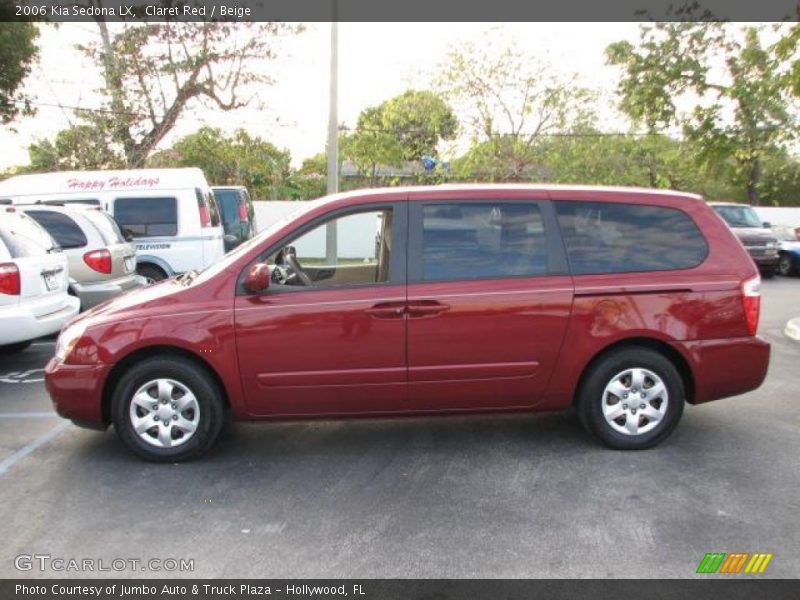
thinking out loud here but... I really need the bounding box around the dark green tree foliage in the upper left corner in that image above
[0,22,39,123]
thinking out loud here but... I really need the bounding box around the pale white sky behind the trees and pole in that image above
[0,23,639,169]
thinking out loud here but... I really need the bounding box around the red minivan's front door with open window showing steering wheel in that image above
[235,202,407,416]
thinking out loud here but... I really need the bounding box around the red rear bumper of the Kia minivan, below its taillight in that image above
[673,337,770,404]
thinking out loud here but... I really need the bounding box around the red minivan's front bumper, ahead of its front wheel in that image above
[44,357,111,429]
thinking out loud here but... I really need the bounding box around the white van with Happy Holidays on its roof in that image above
[0,169,225,281]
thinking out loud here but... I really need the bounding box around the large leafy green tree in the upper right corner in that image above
[606,22,797,205]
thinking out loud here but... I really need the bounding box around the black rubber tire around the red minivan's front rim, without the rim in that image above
[111,355,225,462]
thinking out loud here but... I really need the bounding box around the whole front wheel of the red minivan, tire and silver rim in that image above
[112,356,225,462]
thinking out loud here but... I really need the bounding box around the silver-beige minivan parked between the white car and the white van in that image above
[18,204,145,310]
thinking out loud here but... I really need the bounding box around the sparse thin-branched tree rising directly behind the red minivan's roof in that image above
[437,42,595,181]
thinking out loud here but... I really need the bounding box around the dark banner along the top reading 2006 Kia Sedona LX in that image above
[0,0,798,22]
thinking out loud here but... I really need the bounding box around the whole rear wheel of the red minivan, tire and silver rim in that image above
[578,348,685,450]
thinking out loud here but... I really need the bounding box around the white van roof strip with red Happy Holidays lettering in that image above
[0,168,208,197]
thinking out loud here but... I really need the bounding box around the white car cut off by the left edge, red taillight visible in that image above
[0,207,78,353]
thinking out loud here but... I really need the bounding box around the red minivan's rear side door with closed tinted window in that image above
[407,193,573,411]
